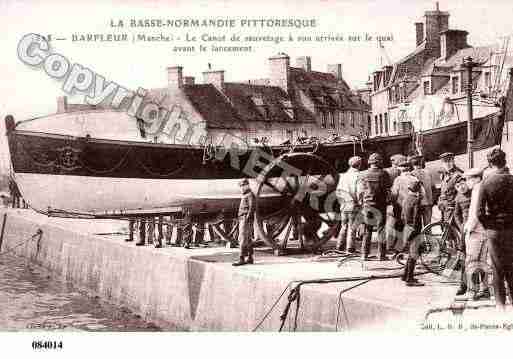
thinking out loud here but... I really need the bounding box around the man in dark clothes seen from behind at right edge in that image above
[477,148,513,309]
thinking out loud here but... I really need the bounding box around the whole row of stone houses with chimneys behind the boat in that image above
[58,3,511,144]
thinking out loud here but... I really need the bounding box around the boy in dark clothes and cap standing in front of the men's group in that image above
[401,178,424,287]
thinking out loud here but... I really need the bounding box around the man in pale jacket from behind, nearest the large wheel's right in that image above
[337,156,362,253]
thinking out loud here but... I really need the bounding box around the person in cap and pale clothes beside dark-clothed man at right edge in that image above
[463,168,490,300]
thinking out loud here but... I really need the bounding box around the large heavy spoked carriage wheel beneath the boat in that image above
[255,153,339,252]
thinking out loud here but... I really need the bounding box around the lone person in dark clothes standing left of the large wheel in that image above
[233,178,255,266]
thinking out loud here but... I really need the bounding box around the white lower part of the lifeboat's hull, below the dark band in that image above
[16,173,286,218]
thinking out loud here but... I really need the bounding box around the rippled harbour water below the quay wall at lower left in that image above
[0,253,163,331]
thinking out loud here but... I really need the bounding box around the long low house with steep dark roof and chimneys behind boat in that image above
[58,53,370,145]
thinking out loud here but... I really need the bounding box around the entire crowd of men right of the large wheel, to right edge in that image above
[337,148,513,307]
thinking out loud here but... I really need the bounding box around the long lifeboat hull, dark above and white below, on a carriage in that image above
[6,108,504,217]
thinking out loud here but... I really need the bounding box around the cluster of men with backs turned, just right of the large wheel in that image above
[337,153,434,286]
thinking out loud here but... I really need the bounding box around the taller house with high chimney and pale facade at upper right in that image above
[370,3,513,136]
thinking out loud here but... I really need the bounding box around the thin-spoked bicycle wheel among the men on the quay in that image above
[419,221,459,272]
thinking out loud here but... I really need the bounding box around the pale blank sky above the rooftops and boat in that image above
[0,0,513,172]
